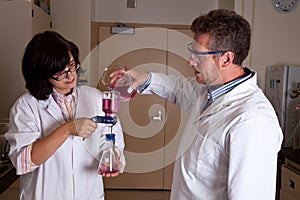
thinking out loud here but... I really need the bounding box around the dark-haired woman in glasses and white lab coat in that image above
[5,31,125,200]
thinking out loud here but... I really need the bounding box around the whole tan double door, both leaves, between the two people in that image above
[98,27,193,189]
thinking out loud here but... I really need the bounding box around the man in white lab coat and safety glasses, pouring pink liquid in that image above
[115,9,283,200]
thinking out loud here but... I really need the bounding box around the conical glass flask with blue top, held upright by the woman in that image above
[98,134,120,175]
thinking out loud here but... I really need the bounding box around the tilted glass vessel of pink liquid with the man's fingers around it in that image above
[100,63,137,101]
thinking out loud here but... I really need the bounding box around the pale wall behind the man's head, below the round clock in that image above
[236,0,300,89]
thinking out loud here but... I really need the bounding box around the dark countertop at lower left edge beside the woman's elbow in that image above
[0,162,18,194]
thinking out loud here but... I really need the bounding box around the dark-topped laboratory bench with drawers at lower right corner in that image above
[276,148,300,200]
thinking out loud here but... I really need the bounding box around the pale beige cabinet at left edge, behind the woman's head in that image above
[0,1,50,119]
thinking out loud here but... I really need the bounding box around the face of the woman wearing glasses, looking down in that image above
[49,54,77,95]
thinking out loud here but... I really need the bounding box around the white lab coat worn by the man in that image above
[143,73,283,200]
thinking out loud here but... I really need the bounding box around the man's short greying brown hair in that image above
[191,9,251,65]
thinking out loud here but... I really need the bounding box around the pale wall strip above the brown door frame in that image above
[93,0,218,25]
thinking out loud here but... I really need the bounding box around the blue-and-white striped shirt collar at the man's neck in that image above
[202,67,255,112]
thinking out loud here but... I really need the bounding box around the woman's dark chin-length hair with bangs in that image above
[22,31,80,100]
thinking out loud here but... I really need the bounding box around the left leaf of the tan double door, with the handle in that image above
[99,27,167,189]
